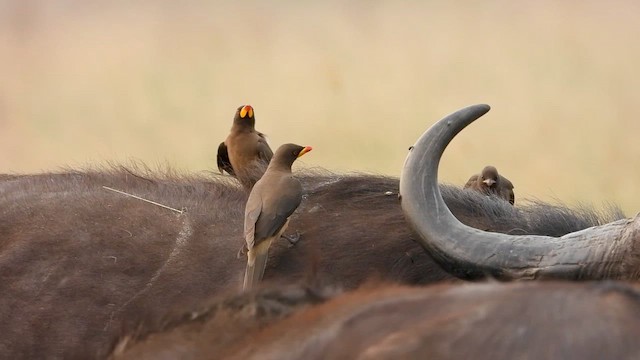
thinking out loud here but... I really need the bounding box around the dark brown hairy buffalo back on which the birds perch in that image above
[0,168,615,358]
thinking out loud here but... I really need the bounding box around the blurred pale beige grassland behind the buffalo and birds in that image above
[0,0,640,215]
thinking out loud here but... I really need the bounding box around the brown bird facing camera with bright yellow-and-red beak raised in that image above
[217,105,273,189]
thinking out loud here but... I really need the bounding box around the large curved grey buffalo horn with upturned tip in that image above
[400,105,640,280]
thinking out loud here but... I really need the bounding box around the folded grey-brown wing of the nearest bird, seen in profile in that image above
[255,177,302,241]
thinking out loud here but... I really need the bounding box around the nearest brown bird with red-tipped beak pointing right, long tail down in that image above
[243,144,311,289]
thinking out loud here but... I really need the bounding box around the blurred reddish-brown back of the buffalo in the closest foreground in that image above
[114,282,640,360]
